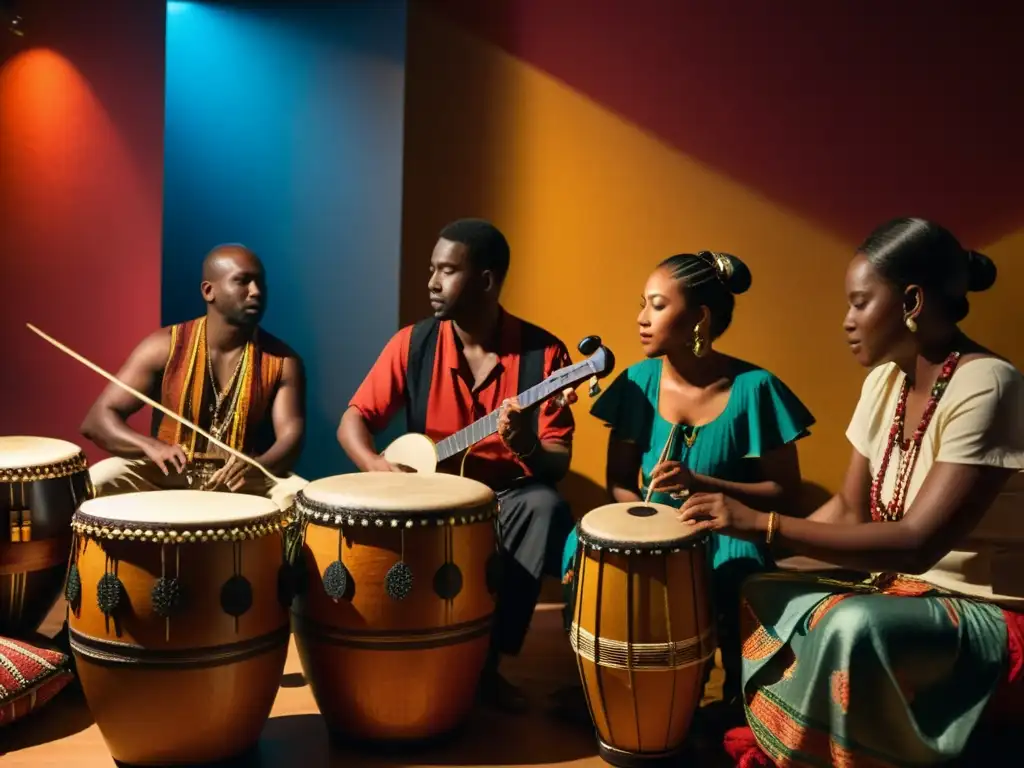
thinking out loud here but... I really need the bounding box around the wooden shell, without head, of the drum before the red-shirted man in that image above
[293,493,497,742]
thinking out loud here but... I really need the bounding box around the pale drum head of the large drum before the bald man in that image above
[75,490,282,531]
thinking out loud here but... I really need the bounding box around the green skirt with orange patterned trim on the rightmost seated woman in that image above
[740,572,1009,768]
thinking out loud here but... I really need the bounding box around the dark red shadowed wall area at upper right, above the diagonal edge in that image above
[425,0,1024,244]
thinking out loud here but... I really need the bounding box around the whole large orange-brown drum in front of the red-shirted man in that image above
[293,472,498,743]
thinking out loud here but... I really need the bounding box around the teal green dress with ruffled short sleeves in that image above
[562,358,814,687]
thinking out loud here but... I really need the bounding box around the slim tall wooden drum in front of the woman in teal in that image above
[569,502,716,767]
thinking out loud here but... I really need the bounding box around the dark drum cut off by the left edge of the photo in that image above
[0,436,92,637]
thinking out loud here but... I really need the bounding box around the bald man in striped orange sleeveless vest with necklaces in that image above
[81,245,305,508]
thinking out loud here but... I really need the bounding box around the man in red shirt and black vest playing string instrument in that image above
[338,219,574,710]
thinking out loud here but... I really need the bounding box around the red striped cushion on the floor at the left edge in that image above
[0,637,75,726]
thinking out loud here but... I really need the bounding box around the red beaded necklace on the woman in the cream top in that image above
[870,352,961,522]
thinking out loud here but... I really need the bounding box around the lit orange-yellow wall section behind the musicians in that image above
[401,2,1024,514]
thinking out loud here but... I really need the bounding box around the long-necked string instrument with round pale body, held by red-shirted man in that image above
[381,336,615,473]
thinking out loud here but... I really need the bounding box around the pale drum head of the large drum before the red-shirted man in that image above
[295,472,498,525]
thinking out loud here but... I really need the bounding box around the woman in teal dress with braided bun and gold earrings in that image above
[563,251,814,701]
